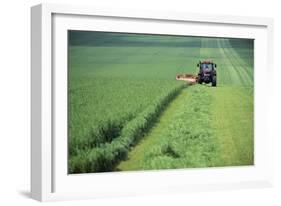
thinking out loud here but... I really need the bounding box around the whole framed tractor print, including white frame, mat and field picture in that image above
[31,4,274,201]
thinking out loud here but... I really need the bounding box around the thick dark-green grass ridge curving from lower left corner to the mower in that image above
[69,85,186,174]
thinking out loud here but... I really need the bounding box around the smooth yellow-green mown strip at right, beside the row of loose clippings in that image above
[211,87,254,166]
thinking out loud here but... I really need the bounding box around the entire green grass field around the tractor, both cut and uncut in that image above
[68,31,254,173]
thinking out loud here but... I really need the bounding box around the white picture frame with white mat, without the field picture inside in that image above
[31,4,274,201]
